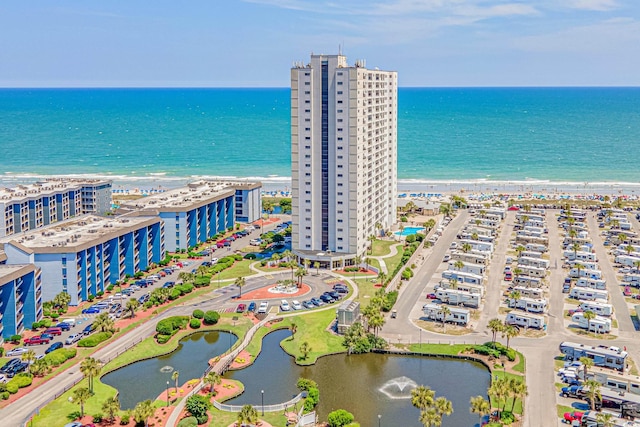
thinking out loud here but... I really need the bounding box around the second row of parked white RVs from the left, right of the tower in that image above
[504,208,549,329]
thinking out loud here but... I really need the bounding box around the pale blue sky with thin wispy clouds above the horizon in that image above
[0,0,640,87]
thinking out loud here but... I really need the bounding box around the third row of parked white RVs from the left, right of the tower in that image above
[558,209,613,333]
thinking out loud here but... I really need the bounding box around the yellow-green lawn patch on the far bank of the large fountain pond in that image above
[278,310,345,365]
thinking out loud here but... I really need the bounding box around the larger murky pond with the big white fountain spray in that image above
[224,330,490,427]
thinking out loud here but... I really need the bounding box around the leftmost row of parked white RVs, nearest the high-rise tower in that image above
[423,207,506,325]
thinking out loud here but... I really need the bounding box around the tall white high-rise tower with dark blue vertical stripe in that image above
[291,55,398,268]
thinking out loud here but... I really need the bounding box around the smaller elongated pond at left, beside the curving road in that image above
[101,331,237,409]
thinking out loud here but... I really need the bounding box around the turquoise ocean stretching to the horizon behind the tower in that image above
[0,88,640,192]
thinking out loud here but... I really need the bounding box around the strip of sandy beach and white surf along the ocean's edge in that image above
[0,172,640,197]
